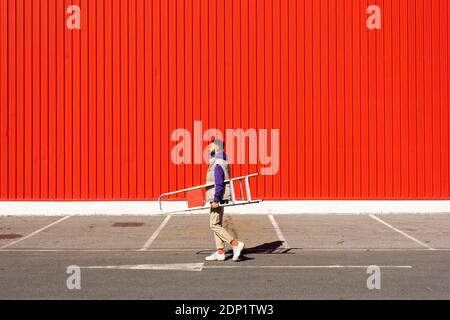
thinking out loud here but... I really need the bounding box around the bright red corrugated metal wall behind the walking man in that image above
[0,0,450,199]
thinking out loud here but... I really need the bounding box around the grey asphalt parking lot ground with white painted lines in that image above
[0,214,450,300]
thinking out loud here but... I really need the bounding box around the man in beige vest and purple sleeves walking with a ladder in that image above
[206,139,244,261]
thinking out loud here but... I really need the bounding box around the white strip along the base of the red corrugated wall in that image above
[0,200,450,216]
